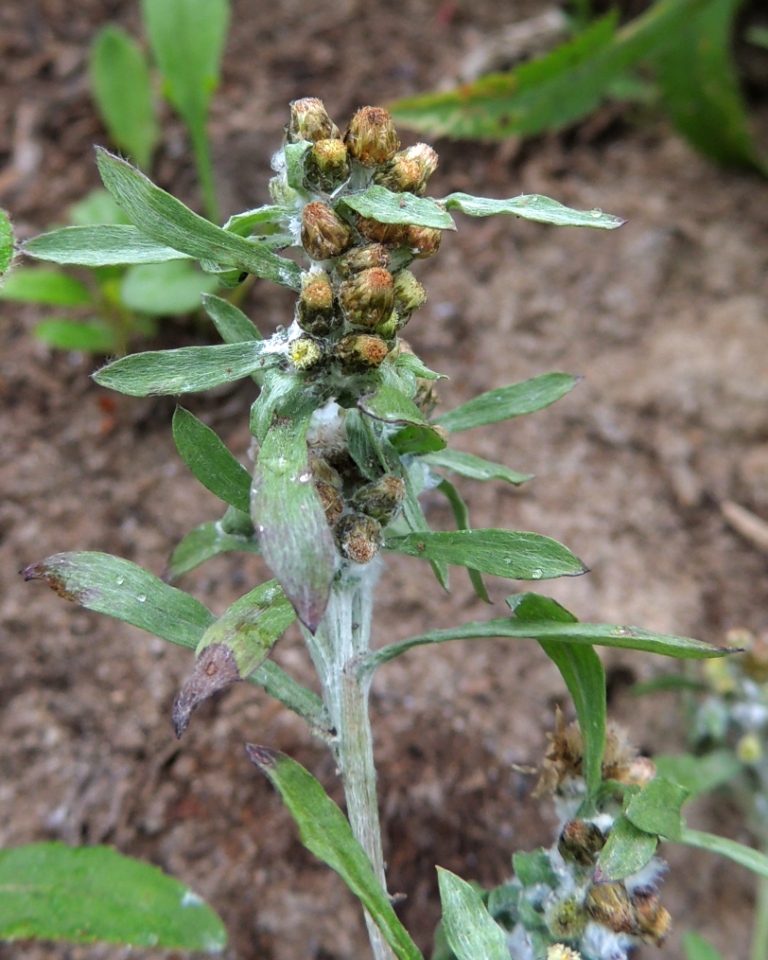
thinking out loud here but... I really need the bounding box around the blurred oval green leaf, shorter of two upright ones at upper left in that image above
[91,24,160,170]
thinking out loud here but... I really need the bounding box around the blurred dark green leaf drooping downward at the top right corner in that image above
[652,0,768,176]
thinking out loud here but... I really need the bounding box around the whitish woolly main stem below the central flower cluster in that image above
[303,564,394,960]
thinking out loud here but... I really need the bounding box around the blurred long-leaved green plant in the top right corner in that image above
[389,0,768,176]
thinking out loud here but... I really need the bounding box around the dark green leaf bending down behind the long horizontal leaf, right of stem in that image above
[507,593,606,801]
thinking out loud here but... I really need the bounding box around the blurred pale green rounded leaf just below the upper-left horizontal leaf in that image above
[120,260,219,317]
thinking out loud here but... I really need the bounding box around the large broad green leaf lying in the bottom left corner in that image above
[0,842,227,953]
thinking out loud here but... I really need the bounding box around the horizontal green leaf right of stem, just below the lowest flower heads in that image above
[384,530,587,580]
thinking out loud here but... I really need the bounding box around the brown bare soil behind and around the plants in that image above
[0,0,768,960]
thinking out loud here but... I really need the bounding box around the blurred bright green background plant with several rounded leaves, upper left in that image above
[0,0,230,354]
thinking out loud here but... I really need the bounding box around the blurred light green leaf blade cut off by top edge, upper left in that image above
[141,0,229,126]
